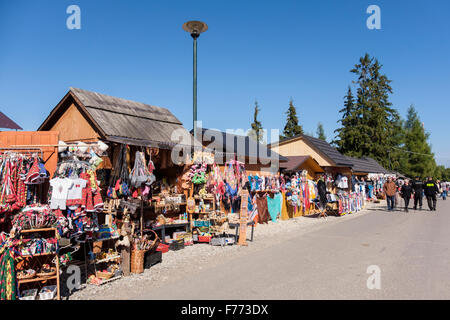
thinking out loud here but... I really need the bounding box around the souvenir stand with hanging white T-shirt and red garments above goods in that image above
[49,141,121,293]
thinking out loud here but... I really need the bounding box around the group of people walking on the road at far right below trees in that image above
[383,177,450,212]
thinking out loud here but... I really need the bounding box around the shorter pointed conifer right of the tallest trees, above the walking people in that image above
[402,105,440,178]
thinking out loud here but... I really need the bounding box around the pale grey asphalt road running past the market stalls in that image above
[134,200,450,300]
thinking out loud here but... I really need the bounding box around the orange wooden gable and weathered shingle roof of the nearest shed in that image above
[38,88,200,149]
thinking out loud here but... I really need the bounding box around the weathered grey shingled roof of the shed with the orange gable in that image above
[38,88,202,149]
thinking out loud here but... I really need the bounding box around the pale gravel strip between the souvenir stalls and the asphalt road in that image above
[68,202,384,300]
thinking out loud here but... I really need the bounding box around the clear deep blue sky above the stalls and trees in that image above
[0,0,450,166]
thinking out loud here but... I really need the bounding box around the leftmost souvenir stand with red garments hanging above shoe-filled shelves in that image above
[0,148,64,300]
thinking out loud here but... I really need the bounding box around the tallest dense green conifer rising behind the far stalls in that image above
[335,54,403,170]
